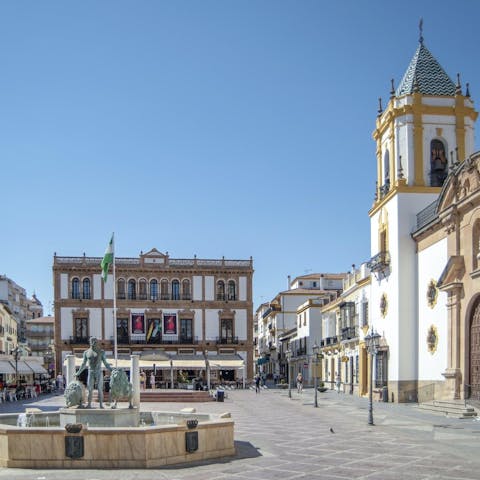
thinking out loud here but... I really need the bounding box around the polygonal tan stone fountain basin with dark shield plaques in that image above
[0,410,235,469]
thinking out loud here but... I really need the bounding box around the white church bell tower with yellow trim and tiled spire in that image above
[369,25,478,401]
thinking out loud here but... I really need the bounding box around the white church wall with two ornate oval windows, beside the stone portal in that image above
[418,238,448,380]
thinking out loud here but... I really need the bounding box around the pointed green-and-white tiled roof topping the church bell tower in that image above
[395,41,455,97]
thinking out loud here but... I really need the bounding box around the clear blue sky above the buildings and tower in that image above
[0,0,480,313]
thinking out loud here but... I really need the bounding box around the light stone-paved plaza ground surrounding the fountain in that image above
[0,389,480,480]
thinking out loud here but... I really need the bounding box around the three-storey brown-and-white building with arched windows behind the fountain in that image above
[53,249,253,381]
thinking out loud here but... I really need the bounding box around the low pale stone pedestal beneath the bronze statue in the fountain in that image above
[59,407,140,427]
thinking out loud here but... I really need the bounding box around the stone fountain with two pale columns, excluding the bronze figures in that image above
[0,344,235,469]
